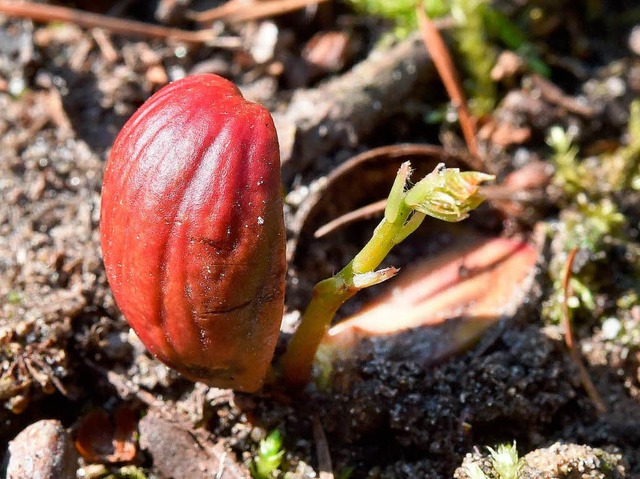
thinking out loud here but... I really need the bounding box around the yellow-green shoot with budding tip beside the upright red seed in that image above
[282,163,493,387]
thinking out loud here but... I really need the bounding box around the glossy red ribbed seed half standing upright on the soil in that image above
[101,75,286,392]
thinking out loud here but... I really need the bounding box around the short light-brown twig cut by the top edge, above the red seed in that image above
[187,0,328,23]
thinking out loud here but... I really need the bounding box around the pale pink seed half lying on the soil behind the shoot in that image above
[319,238,539,366]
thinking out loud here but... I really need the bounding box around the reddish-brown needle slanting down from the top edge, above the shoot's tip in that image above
[416,0,486,171]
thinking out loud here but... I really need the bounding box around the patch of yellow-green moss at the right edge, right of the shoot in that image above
[543,113,640,323]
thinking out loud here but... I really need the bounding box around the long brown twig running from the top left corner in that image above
[0,0,240,48]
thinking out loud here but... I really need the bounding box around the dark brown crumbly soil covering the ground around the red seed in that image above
[0,0,640,479]
